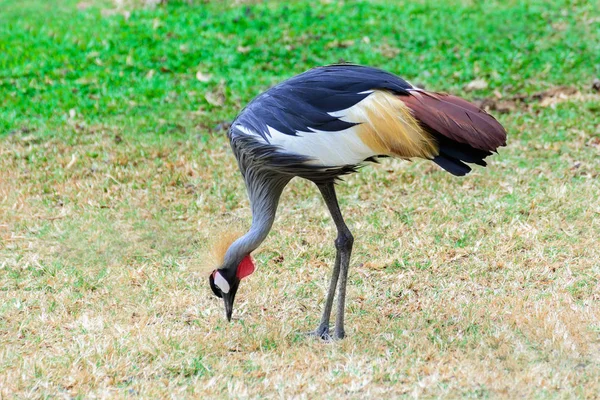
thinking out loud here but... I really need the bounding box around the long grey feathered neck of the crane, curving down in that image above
[223,171,289,271]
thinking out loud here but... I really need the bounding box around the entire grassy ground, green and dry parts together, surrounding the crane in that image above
[0,0,600,398]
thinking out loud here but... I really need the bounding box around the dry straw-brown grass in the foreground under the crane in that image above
[0,94,600,398]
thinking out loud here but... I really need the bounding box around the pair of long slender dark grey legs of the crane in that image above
[316,182,354,339]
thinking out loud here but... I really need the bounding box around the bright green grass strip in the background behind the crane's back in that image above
[0,1,600,134]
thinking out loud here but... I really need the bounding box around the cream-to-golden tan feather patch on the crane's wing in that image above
[343,90,438,159]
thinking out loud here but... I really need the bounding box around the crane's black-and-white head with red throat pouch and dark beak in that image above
[209,255,254,321]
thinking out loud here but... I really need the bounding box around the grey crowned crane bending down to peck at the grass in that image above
[210,64,506,339]
